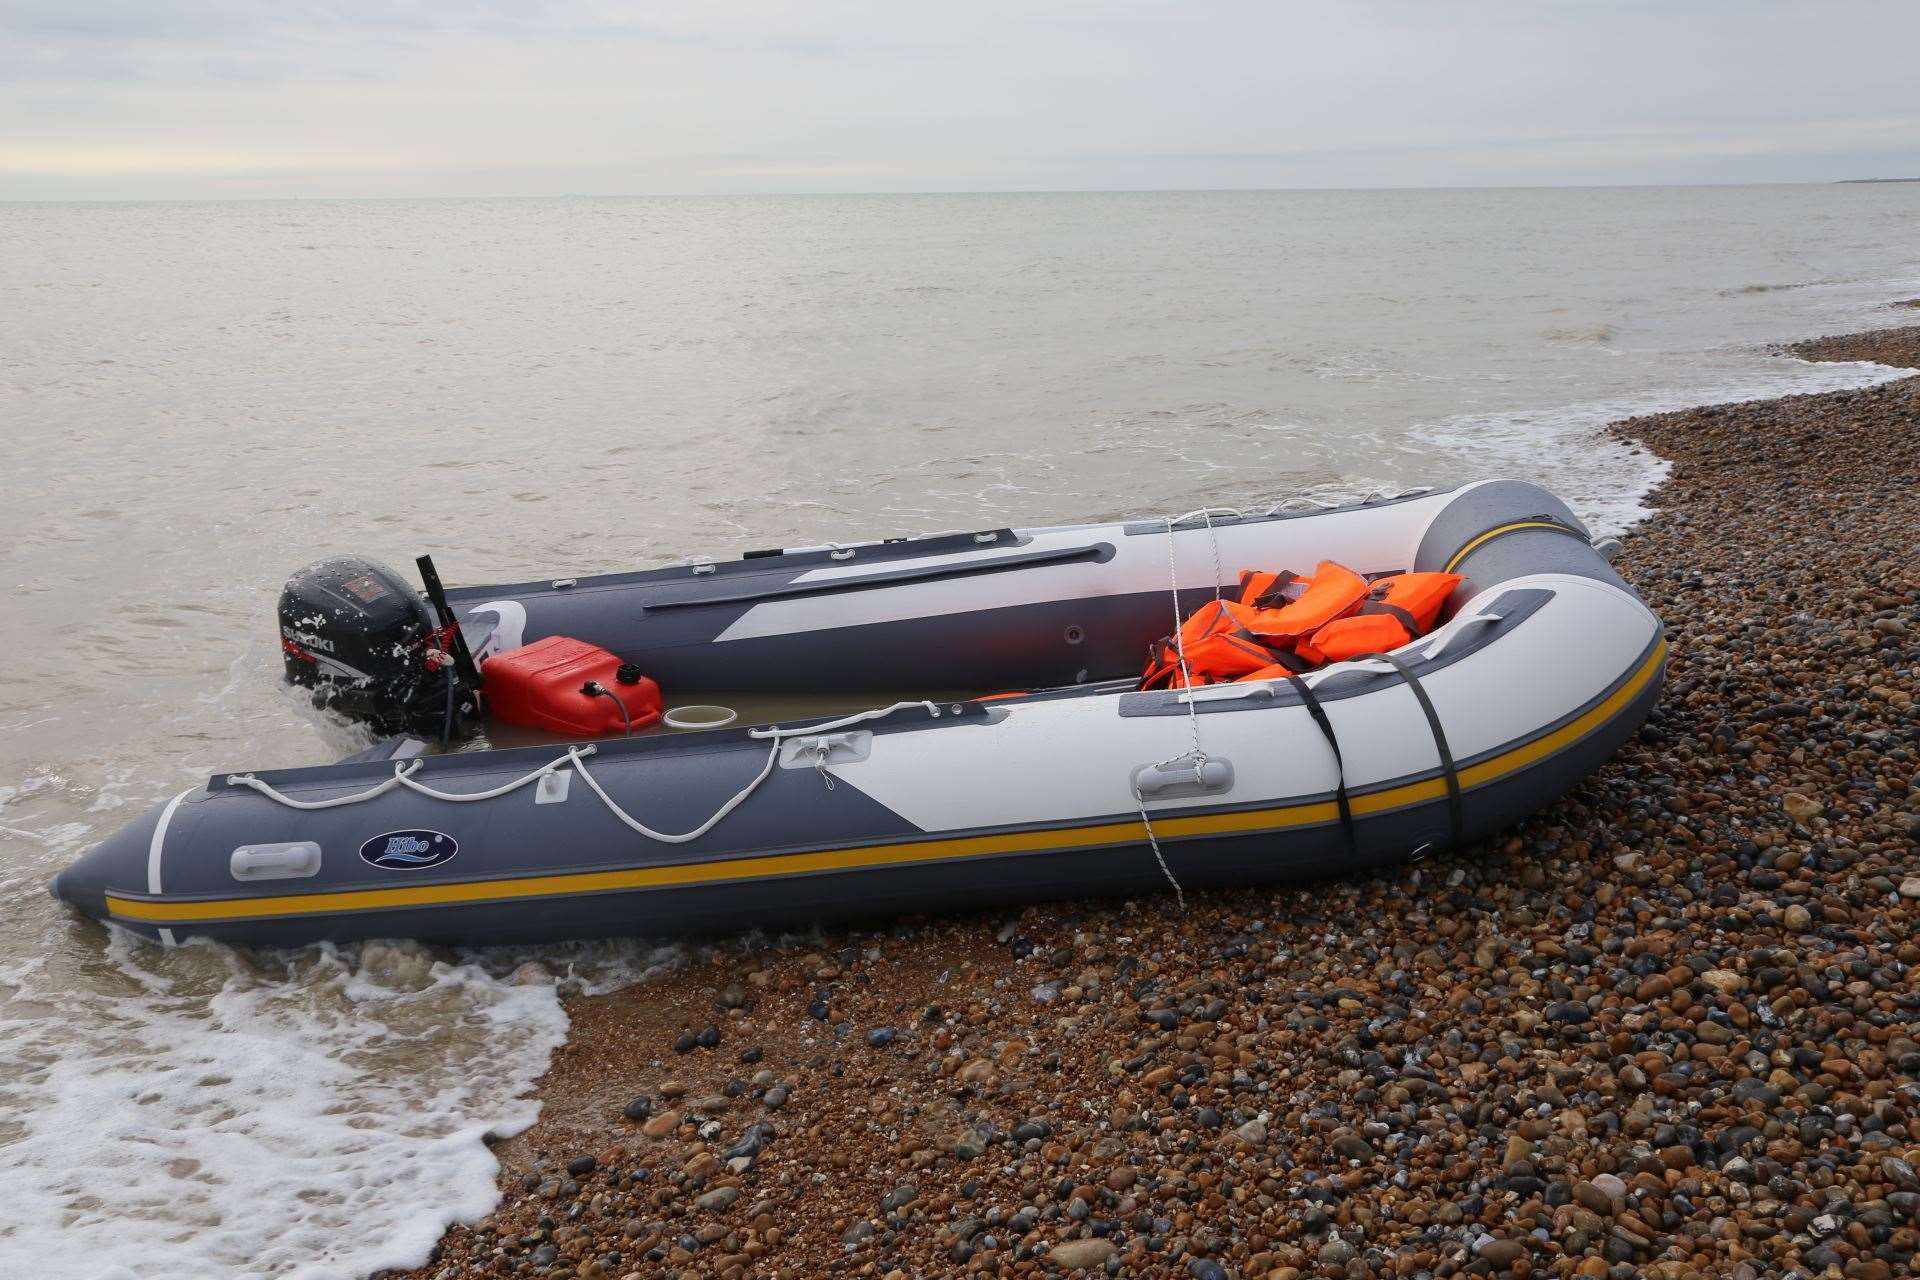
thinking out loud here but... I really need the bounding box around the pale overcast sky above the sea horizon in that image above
[0,0,1920,200]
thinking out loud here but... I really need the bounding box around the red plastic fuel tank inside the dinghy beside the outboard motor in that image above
[480,635,660,737]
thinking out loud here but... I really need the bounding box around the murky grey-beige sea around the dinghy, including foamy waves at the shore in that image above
[0,184,1920,1280]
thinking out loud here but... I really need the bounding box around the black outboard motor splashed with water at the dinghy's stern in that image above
[280,557,474,739]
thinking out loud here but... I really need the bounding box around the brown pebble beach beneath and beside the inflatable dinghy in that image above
[401,314,1920,1280]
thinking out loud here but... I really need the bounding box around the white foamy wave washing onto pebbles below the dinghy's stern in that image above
[0,935,670,1280]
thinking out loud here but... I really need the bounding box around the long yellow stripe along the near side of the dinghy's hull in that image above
[108,644,1667,925]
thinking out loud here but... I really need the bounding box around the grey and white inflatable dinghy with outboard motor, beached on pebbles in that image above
[52,480,1667,946]
